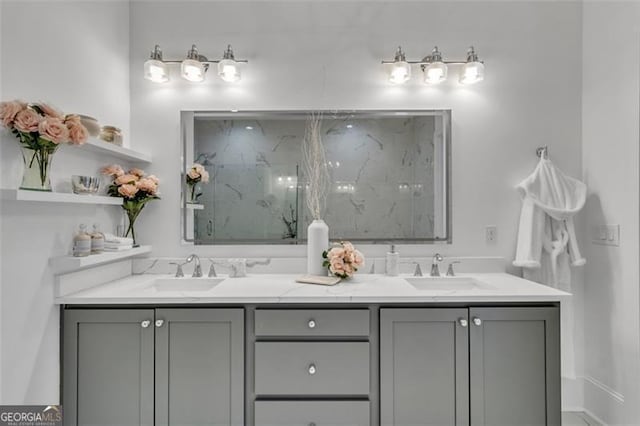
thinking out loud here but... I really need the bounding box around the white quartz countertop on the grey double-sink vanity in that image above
[56,273,571,305]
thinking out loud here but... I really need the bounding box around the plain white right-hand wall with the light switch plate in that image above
[582,2,640,425]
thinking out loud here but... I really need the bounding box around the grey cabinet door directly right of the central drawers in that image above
[380,309,469,426]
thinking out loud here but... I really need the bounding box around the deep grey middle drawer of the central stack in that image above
[255,342,369,395]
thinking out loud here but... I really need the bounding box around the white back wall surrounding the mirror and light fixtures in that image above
[130,1,583,409]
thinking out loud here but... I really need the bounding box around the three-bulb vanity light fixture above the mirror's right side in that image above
[382,46,484,85]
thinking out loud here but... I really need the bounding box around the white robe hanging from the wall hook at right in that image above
[513,158,587,378]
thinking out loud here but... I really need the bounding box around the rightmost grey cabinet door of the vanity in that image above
[469,308,560,426]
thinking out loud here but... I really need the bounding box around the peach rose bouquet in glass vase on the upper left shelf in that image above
[0,100,89,191]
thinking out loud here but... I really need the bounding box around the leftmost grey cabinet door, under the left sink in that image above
[63,309,154,426]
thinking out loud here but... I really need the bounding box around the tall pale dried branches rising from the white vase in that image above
[302,112,331,220]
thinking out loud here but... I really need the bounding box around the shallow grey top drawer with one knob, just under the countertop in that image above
[255,309,369,337]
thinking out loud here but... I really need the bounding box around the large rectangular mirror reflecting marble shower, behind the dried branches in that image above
[182,110,451,244]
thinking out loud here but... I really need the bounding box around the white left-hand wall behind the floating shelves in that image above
[0,1,129,404]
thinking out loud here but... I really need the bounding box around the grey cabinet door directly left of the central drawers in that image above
[155,309,244,426]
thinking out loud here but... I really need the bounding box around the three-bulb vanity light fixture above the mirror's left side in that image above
[144,44,249,83]
